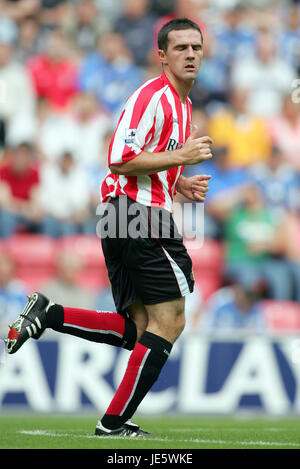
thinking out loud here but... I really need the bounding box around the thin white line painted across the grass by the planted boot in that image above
[19,430,300,448]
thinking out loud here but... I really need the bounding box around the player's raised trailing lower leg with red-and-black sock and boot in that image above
[6,293,147,354]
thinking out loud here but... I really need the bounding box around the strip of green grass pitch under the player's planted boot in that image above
[0,413,300,450]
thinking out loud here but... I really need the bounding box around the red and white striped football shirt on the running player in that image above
[101,73,192,211]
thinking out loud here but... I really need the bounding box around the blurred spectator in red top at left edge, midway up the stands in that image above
[0,143,41,238]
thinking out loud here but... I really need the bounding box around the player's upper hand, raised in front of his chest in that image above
[180,126,213,165]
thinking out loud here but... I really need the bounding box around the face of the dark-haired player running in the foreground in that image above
[159,29,203,81]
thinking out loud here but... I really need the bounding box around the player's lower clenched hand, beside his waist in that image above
[176,174,211,202]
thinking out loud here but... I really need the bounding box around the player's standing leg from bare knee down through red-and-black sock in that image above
[95,297,185,435]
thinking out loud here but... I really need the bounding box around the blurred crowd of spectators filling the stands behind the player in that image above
[0,0,300,329]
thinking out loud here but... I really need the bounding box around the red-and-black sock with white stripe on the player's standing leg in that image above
[101,331,172,429]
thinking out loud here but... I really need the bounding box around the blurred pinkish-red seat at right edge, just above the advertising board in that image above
[262,300,300,332]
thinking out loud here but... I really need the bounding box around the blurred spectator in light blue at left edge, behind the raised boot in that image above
[0,248,27,330]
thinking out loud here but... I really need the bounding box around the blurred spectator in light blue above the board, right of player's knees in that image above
[202,278,267,334]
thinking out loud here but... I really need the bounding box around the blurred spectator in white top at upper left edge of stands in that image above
[0,17,36,145]
